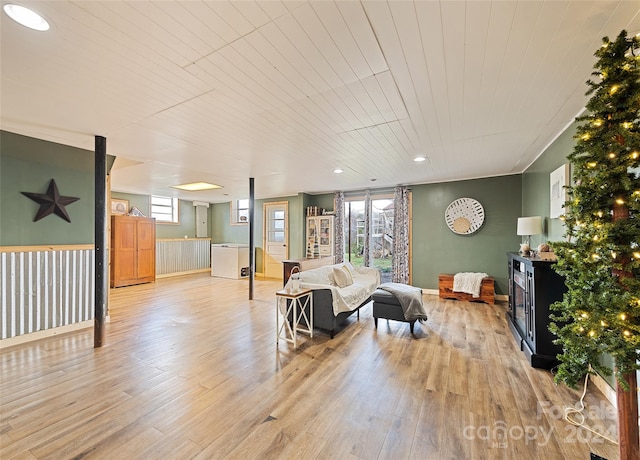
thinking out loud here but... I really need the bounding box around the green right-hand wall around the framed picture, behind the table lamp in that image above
[522,123,577,244]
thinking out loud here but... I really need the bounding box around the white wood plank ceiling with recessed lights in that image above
[0,0,640,202]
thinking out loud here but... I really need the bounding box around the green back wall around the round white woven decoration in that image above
[411,175,522,294]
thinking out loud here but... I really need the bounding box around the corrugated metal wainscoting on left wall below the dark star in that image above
[0,245,95,339]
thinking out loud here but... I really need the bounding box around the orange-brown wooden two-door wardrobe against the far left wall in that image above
[110,216,156,287]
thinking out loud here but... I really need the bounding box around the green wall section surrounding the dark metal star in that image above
[0,131,95,246]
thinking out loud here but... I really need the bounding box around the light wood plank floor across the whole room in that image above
[0,274,617,460]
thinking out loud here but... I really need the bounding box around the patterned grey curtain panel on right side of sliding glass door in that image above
[391,186,409,284]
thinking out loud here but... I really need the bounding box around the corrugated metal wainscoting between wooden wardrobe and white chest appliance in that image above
[156,238,211,278]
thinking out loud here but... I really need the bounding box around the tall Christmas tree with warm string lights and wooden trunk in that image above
[550,31,640,459]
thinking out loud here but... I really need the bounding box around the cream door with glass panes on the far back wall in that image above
[264,201,289,279]
